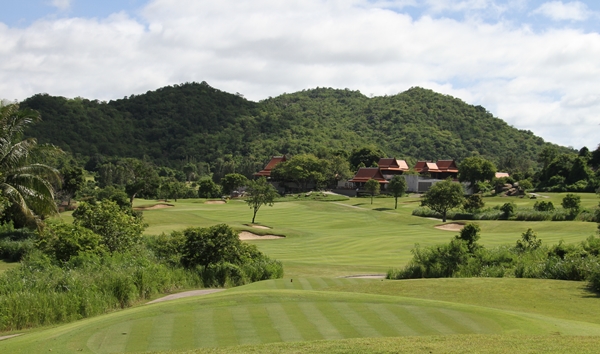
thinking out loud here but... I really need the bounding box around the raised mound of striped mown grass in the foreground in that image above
[0,282,600,353]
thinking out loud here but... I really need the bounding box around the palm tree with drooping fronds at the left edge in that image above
[0,104,60,227]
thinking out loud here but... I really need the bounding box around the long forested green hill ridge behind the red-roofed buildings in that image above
[21,82,564,165]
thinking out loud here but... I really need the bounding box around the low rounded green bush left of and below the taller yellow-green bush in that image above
[37,222,105,262]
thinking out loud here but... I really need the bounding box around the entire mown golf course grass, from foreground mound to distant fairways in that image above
[0,193,600,353]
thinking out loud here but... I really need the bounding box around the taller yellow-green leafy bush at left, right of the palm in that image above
[73,200,146,252]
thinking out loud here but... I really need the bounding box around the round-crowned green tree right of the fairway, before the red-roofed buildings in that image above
[421,178,464,222]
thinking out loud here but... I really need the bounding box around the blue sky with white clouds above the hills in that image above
[0,0,600,149]
